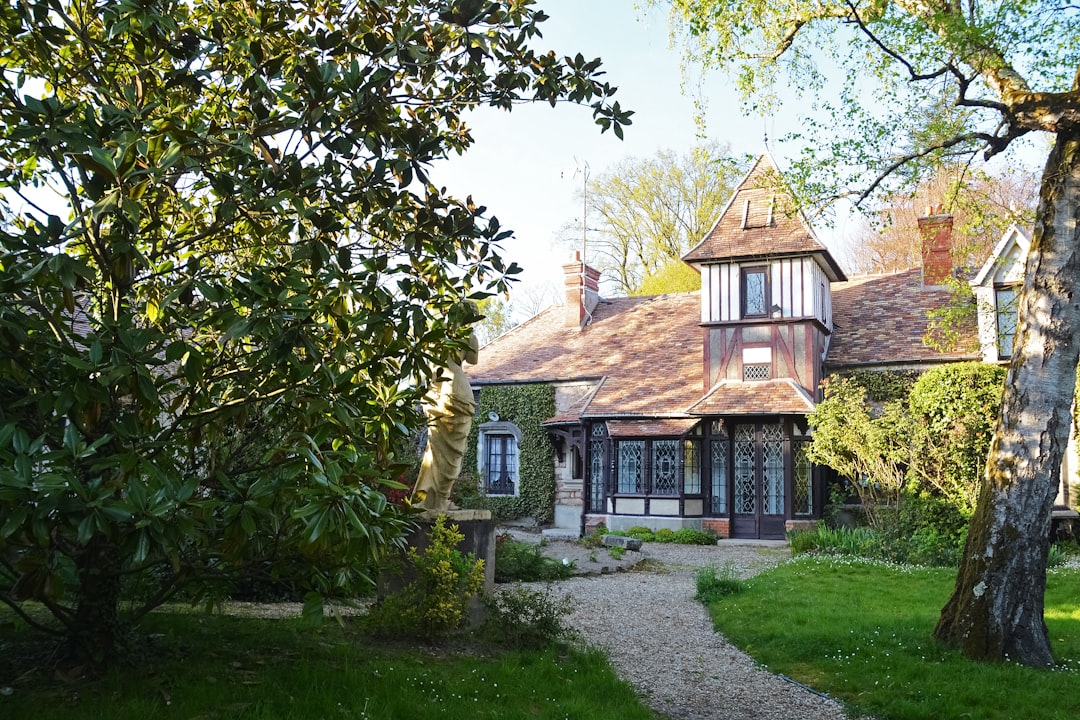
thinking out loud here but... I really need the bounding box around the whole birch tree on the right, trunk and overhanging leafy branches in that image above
[672,0,1080,666]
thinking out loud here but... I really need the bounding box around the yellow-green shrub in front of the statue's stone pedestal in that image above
[367,515,484,637]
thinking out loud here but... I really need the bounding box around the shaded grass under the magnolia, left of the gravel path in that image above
[0,612,654,720]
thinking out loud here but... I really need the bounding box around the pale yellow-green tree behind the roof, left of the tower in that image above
[574,141,741,295]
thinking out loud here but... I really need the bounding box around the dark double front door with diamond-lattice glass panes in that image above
[731,422,786,540]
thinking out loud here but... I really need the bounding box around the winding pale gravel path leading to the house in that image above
[540,543,847,720]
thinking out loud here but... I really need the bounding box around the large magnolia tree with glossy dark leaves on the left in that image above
[0,0,629,662]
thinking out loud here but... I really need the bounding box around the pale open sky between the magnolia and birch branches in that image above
[433,0,812,306]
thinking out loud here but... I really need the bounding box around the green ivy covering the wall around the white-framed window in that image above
[454,384,555,525]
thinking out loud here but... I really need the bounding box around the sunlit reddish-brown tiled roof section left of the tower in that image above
[464,293,703,422]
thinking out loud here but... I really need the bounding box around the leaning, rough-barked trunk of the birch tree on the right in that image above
[934,133,1080,666]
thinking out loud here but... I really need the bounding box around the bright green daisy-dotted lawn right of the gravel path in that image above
[708,557,1080,720]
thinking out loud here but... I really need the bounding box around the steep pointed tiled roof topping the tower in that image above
[683,152,847,281]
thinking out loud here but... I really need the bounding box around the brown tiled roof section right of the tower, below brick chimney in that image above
[825,269,981,369]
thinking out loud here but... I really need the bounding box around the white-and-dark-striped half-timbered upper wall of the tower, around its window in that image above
[701,257,833,330]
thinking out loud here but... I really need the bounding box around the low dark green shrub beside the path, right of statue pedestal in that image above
[481,585,573,650]
